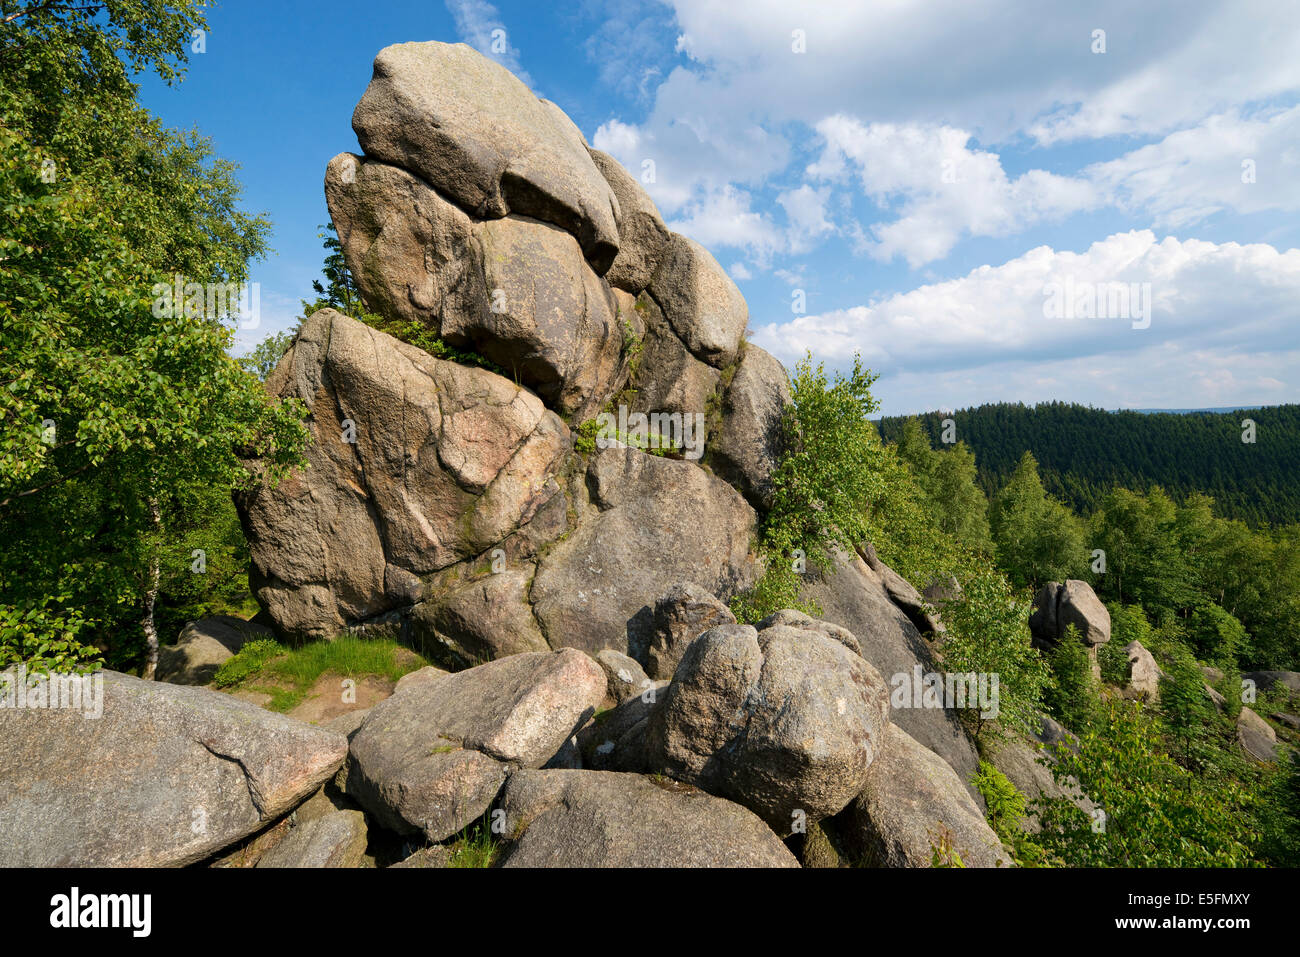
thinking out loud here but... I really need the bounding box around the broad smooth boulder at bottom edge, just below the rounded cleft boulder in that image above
[501,771,798,867]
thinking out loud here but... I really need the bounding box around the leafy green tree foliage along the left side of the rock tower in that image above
[0,1,307,667]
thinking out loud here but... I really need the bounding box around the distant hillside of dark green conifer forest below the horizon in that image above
[880,402,1300,525]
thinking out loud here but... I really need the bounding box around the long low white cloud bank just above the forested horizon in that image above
[755,230,1300,406]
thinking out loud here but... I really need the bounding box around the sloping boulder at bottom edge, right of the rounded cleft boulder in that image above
[836,724,1013,867]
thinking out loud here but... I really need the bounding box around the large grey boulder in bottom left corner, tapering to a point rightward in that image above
[0,671,347,867]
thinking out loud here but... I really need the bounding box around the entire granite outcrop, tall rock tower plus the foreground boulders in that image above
[0,43,1013,867]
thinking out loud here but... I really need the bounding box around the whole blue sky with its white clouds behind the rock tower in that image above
[142,0,1300,413]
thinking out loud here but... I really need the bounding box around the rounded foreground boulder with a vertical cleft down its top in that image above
[646,624,889,835]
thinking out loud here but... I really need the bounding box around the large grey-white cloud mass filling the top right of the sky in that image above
[595,0,1300,267]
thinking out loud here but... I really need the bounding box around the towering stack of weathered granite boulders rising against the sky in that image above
[238,43,769,650]
